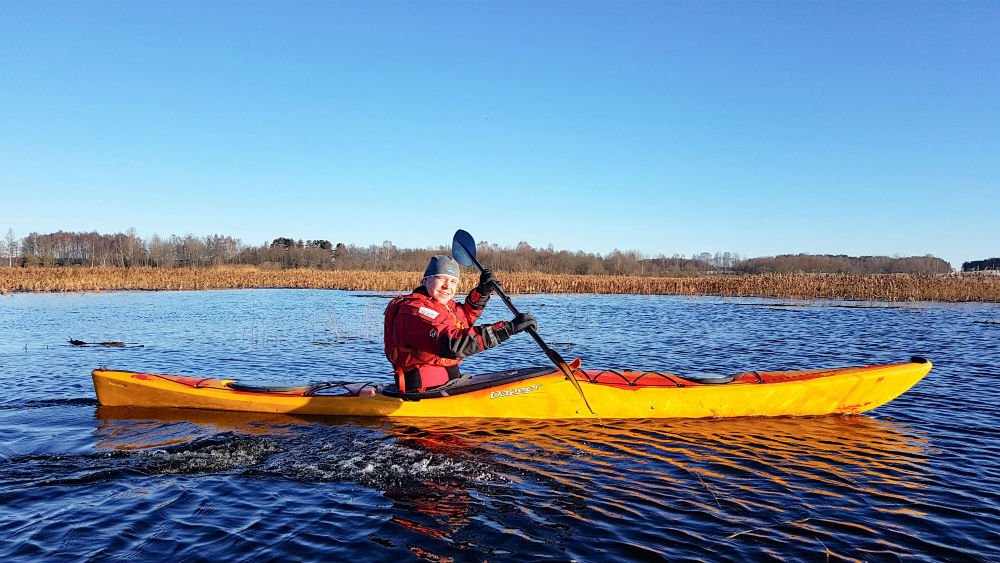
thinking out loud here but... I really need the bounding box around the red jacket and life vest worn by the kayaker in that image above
[384,287,482,393]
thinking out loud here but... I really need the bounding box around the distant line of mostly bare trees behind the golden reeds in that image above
[0,229,960,276]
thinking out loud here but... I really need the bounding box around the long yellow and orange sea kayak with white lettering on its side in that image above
[92,356,931,419]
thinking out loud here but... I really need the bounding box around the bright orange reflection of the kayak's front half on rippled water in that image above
[383,416,927,502]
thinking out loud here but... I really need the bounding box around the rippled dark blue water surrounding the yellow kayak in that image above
[0,290,1000,562]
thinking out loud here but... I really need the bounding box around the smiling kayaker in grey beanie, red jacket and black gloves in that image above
[385,255,538,393]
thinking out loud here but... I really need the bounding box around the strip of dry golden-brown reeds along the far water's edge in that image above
[0,266,1000,302]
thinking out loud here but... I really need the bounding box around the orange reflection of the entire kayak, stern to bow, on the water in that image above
[94,407,927,502]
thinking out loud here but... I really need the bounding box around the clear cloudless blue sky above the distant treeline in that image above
[0,0,1000,267]
